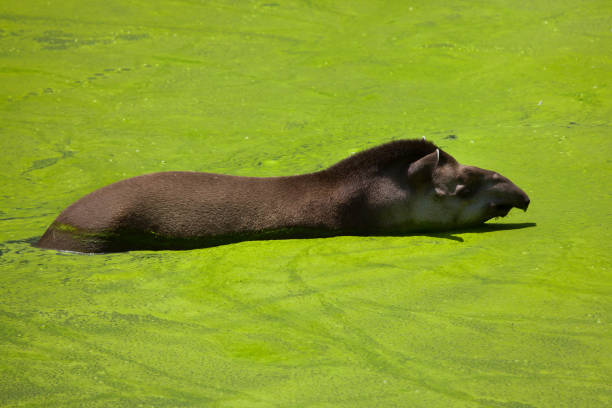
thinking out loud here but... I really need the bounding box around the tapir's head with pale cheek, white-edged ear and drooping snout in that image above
[407,149,529,229]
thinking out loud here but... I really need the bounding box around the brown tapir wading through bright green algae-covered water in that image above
[38,140,529,252]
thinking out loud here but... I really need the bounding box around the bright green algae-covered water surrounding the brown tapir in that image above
[0,0,612,408]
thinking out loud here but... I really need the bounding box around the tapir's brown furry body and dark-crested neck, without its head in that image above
[37,140,524,252]
